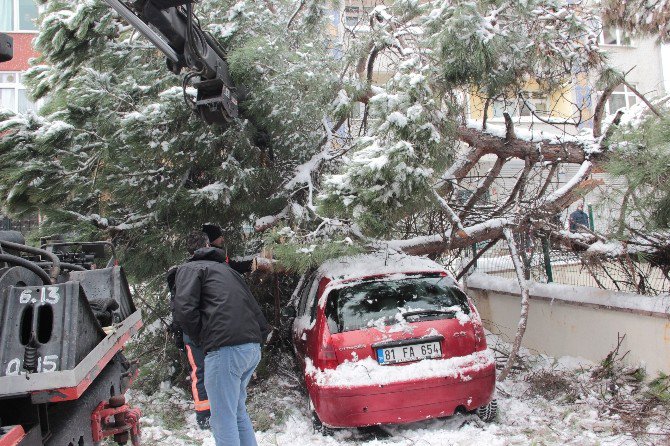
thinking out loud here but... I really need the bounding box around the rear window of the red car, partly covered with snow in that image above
[325,275,470,333]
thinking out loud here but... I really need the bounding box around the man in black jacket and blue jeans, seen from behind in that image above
[173,230,269,446]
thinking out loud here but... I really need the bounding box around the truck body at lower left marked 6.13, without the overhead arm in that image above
[0,235,142,446]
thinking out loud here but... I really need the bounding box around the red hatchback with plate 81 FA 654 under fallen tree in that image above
[284,253,497,432]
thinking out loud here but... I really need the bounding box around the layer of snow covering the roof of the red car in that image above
[318,251,446,280]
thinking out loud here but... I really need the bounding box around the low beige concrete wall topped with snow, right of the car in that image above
[466,273,670,376]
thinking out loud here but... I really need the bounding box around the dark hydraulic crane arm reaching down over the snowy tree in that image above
[105,0,238,125]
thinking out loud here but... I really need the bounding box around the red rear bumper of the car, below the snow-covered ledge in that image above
[308,364,495,427]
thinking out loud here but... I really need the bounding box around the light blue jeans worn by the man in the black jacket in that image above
[205,343,261,446]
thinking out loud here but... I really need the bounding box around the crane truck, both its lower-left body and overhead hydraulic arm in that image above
[0,0,239,440]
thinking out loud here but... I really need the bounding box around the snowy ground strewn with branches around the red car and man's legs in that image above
[130,337,670,446]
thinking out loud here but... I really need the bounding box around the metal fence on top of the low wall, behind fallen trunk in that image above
[451,237,670,295]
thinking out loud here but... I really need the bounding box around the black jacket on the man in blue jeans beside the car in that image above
[173,248,269,352]
